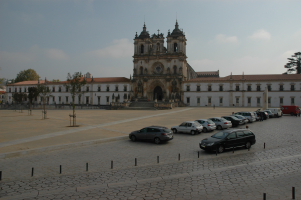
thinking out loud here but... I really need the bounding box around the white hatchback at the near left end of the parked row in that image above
[171,121,203,135]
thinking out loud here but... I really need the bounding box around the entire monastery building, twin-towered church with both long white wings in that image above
[6,22,301,107]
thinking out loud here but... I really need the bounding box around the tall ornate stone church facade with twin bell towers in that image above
[132,22,197,101]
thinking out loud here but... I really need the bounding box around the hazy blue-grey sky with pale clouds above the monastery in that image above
[0,0,301,80]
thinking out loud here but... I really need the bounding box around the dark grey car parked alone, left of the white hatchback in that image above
[129,126,173,144]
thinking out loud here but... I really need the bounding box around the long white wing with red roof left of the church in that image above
[6,77,131,105]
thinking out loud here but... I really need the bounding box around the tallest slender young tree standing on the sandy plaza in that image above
[64,72,87,126]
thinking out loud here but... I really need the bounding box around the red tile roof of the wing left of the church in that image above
[8,77,130,86]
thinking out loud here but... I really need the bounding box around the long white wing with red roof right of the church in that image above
[182,74,301,107]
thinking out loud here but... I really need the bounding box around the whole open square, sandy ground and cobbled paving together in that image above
[0,107,301,199]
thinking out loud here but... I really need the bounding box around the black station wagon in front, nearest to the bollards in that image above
[200,129,256,153]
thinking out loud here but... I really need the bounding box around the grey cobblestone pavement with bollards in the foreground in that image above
[0,116,301,199]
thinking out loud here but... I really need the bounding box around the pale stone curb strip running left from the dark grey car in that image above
[0,136,129,159]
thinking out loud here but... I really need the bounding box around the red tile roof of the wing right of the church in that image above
[184,74,301,83]
